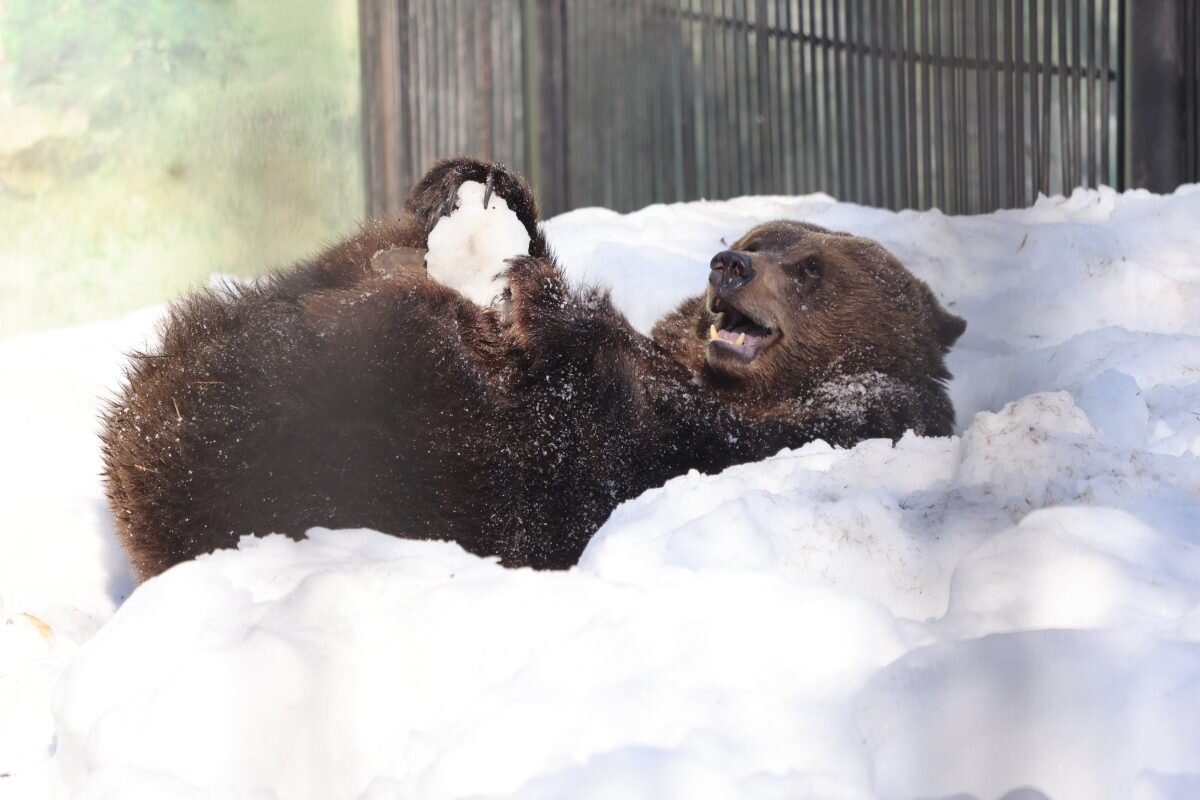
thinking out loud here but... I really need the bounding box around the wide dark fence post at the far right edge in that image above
[1122,0,1192,192]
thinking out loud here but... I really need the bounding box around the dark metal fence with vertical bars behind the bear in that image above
[360,0,1200,219]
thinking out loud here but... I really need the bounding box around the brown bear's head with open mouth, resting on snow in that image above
[655,221,966,399]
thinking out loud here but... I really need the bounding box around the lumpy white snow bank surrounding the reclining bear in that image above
[0,186,1200,800]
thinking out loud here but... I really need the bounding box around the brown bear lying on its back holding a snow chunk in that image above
[102,158,965,579]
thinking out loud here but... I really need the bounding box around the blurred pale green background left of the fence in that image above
[0,0,364,337]
